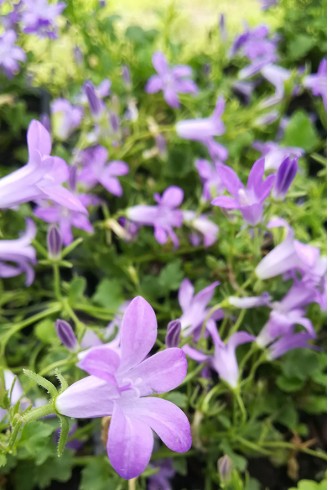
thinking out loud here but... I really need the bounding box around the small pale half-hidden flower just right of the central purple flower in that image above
[182,211,219,247]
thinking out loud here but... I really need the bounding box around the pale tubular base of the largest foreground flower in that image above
[56,376,118,419]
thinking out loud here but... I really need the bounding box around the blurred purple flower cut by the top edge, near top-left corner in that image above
[22,0,65,39]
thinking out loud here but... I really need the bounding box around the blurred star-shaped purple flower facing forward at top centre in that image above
[145,52,198,109]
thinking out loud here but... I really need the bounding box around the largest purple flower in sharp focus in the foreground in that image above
[56,297,191,479]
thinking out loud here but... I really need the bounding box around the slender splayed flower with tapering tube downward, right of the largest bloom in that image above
[183,324,255,389]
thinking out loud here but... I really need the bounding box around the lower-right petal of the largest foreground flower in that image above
[130,397,192,453]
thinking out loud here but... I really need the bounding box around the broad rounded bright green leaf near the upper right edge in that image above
[282,111,319,151]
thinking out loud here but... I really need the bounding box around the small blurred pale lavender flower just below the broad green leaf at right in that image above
[252,141,304,170]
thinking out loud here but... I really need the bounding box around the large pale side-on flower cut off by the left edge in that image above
[0,121,87,213]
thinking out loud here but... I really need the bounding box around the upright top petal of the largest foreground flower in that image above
[121,296,157,369]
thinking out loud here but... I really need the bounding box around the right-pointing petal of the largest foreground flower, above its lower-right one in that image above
[127,347,188,396]
